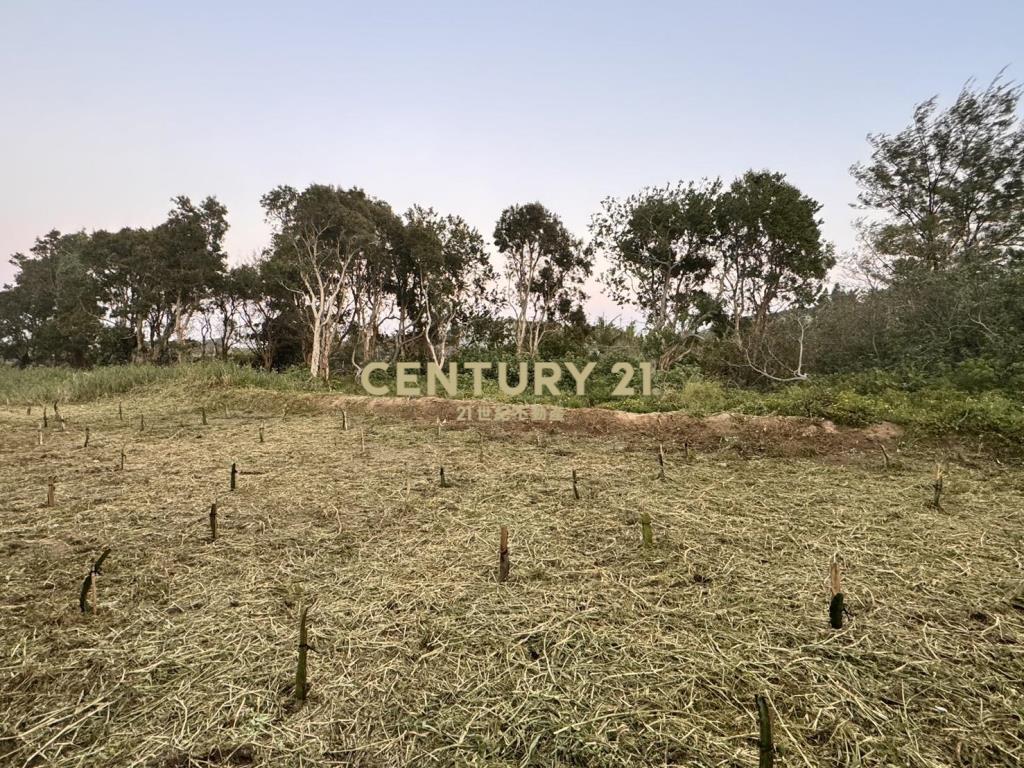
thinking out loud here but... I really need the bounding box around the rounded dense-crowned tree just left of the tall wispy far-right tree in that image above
[718,171,836,379]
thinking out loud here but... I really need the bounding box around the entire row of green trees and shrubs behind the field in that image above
[0,79,1024,383]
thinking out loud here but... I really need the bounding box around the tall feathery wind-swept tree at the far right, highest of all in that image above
[851,78,1024,271]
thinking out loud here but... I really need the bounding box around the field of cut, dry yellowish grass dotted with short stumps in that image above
[0,386,1024,768]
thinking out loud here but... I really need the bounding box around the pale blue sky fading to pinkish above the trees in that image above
[0,0,1024,319]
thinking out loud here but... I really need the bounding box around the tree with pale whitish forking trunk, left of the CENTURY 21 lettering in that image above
[261,184,393,380]
